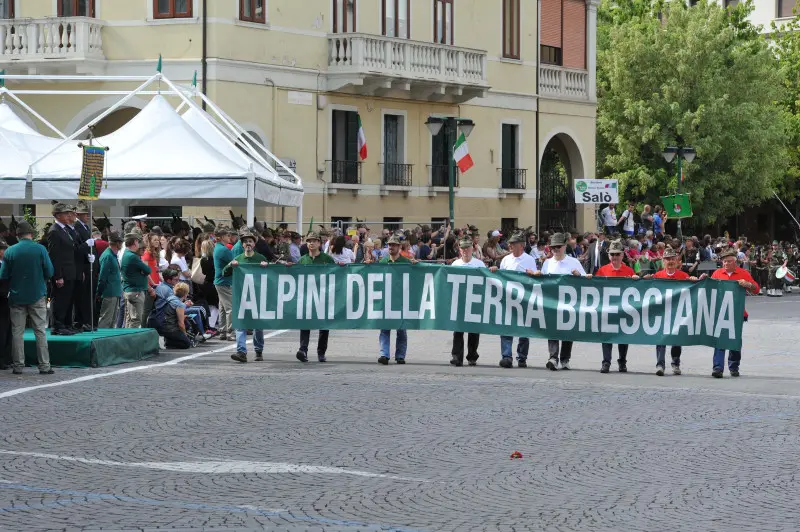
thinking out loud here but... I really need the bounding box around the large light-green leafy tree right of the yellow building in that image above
[597,0,789,223]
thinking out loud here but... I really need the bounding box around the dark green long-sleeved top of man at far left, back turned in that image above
[0,238,53,305]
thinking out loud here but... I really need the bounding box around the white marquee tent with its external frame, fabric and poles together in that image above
[0,73,303,227]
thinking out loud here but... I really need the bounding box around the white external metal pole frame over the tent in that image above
[0,72,303,232]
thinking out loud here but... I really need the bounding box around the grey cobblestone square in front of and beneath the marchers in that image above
[0,296,800,531]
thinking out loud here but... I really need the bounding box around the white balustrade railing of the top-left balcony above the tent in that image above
[0,17,104,62]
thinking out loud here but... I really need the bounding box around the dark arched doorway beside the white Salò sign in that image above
[539,133,583,231]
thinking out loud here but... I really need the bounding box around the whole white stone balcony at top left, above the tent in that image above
[0,17,105,74]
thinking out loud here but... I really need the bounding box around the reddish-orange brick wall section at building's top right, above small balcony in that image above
[541,0,586,68]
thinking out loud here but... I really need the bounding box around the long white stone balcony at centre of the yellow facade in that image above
[327,33,489,103]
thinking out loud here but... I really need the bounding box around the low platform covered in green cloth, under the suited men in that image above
[25,329,158,368]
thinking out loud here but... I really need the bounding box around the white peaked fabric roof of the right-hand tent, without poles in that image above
[29,96,303,206]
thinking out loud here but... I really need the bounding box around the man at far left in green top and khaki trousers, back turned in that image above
[0,221,54,375]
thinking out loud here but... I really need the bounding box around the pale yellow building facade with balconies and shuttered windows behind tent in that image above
[0,0,599,231]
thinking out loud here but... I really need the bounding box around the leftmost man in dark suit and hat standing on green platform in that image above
[47,203,83,334]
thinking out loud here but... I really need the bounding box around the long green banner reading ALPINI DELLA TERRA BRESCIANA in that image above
[233,264,745,350]
